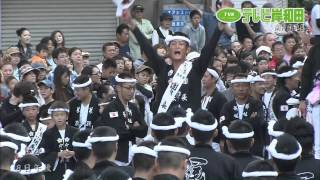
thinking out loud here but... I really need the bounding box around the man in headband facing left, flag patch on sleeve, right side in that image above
[272,66,300,119]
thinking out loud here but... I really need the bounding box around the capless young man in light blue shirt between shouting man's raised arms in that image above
[182,10,206,52]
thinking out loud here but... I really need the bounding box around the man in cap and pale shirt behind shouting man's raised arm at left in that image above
[129,4,154,60]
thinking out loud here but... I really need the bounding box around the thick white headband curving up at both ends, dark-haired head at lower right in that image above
[267,139,302,160]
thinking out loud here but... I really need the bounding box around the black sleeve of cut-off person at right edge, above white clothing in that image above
[300,43,320,100]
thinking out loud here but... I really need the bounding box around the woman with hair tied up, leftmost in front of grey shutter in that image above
[16,27,32,63]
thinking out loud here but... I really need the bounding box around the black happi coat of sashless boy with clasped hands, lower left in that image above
[40,125,78,180]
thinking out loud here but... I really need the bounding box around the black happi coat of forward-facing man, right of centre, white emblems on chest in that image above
[220,97,267,157]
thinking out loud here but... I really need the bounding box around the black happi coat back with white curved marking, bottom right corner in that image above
[295,154,320,180]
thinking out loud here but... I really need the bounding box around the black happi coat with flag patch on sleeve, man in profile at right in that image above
[272,86,291,119]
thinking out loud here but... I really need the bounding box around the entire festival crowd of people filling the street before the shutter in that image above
[0,0,320,180]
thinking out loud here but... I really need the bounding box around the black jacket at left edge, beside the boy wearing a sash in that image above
[0,97,23,127]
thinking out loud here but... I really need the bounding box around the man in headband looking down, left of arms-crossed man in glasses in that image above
[68,75,99,130]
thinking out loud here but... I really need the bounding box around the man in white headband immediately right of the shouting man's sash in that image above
[201,68,227,119]
